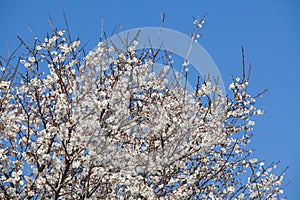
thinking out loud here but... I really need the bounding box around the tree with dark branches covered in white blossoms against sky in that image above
[0,24,283,199]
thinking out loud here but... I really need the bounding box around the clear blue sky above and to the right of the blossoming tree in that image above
[0,0,300,199]
